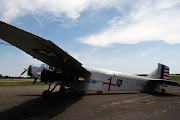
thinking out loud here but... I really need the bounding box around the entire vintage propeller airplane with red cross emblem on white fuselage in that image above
[0,21,180,98]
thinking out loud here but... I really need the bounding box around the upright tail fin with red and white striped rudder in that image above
[147,63,169,80]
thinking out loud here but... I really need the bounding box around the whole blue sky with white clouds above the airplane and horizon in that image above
[0,0,180,76]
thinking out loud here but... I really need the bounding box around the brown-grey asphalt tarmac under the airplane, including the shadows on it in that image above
[0,86,180,120]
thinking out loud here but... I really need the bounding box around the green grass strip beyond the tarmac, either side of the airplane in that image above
[0,75,180,87]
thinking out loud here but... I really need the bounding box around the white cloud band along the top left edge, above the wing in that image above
[0,0,134,22]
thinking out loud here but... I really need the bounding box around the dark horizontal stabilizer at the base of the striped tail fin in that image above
[150,79,180,86]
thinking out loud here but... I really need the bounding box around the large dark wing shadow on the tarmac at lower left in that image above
[0,90,85,120]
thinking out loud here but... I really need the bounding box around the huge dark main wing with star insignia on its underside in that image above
[0,21,90,75]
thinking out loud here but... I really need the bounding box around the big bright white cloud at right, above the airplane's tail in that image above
[78,0,180,46]
